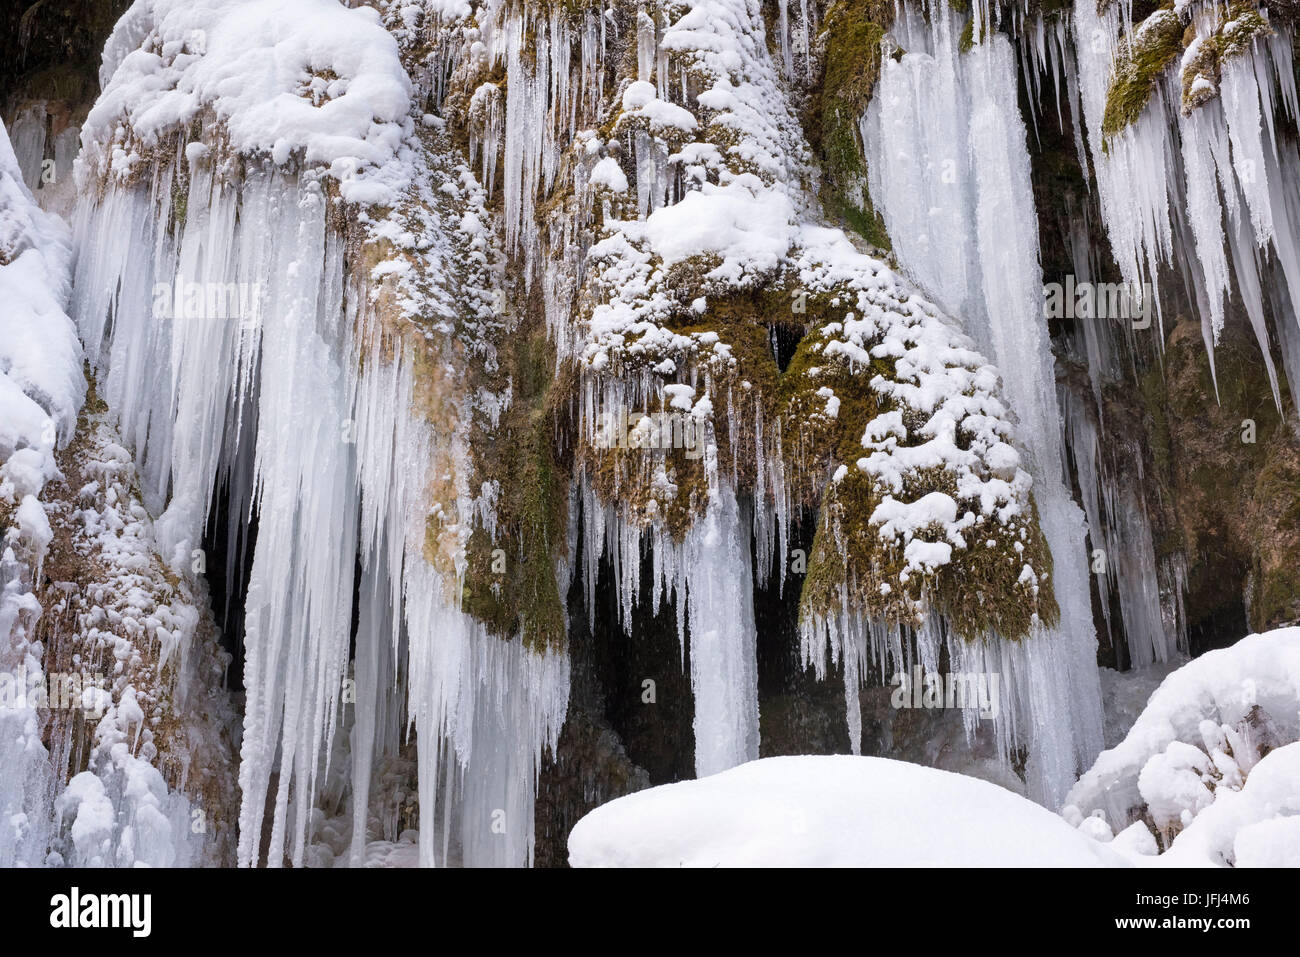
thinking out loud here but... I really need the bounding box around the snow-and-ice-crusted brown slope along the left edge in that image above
[0,111,226,866]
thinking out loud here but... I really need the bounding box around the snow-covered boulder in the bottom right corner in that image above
[1062,628,1300,867]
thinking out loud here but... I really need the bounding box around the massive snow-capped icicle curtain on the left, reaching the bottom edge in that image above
[65,5,568,865]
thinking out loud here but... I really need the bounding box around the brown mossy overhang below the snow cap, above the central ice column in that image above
[577,263,1057,638]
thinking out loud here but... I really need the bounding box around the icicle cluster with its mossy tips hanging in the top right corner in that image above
[1071,0,1300,404]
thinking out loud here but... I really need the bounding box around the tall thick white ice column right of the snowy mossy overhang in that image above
[863,3,1101,805]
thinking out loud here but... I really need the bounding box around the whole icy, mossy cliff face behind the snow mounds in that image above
[0,0,1300,865]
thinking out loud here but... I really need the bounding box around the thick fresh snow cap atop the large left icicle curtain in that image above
[82,0,411,203]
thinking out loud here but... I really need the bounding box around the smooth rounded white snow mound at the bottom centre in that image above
[569,755,1125,867]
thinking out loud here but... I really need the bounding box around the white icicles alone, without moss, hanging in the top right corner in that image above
[1073,0,1296,408]
